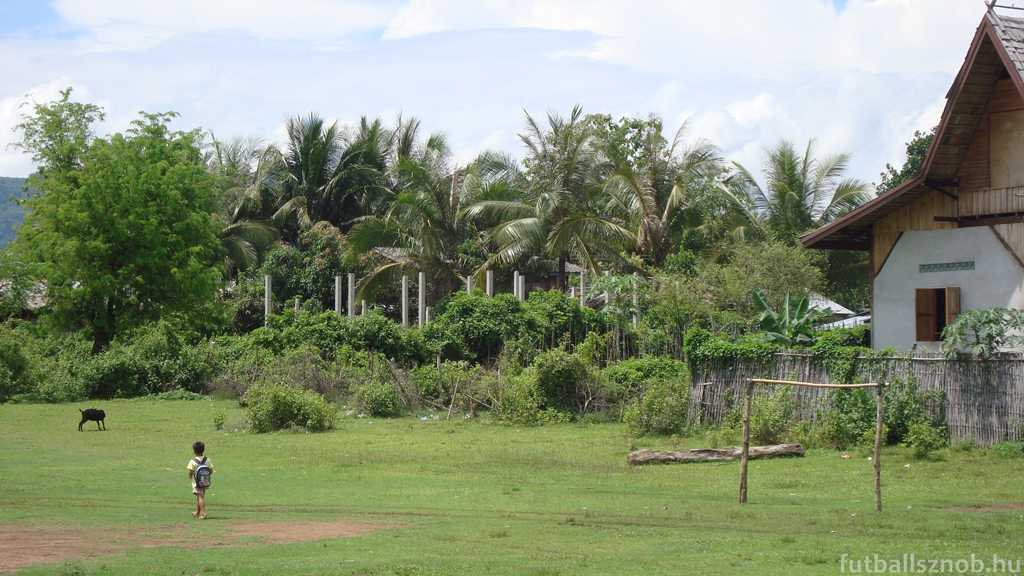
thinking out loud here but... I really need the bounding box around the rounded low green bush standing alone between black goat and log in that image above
[246,382,335,434]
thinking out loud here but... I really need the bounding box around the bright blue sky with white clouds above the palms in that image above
[0,0,984,181]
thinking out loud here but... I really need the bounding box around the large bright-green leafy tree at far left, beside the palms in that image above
[16,105,220,354]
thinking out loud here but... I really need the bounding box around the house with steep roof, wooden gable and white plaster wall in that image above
[801,5,1024,351]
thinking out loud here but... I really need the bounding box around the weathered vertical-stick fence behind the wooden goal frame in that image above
[687,352,1024,445]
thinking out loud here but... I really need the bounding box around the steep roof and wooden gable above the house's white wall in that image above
[801,9,1024,255]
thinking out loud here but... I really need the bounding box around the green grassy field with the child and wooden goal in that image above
[0,401,1024,575]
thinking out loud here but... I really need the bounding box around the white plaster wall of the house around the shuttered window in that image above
[871,227,1024,352]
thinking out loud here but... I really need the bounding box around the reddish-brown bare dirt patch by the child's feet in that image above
[0,521,402,574]
